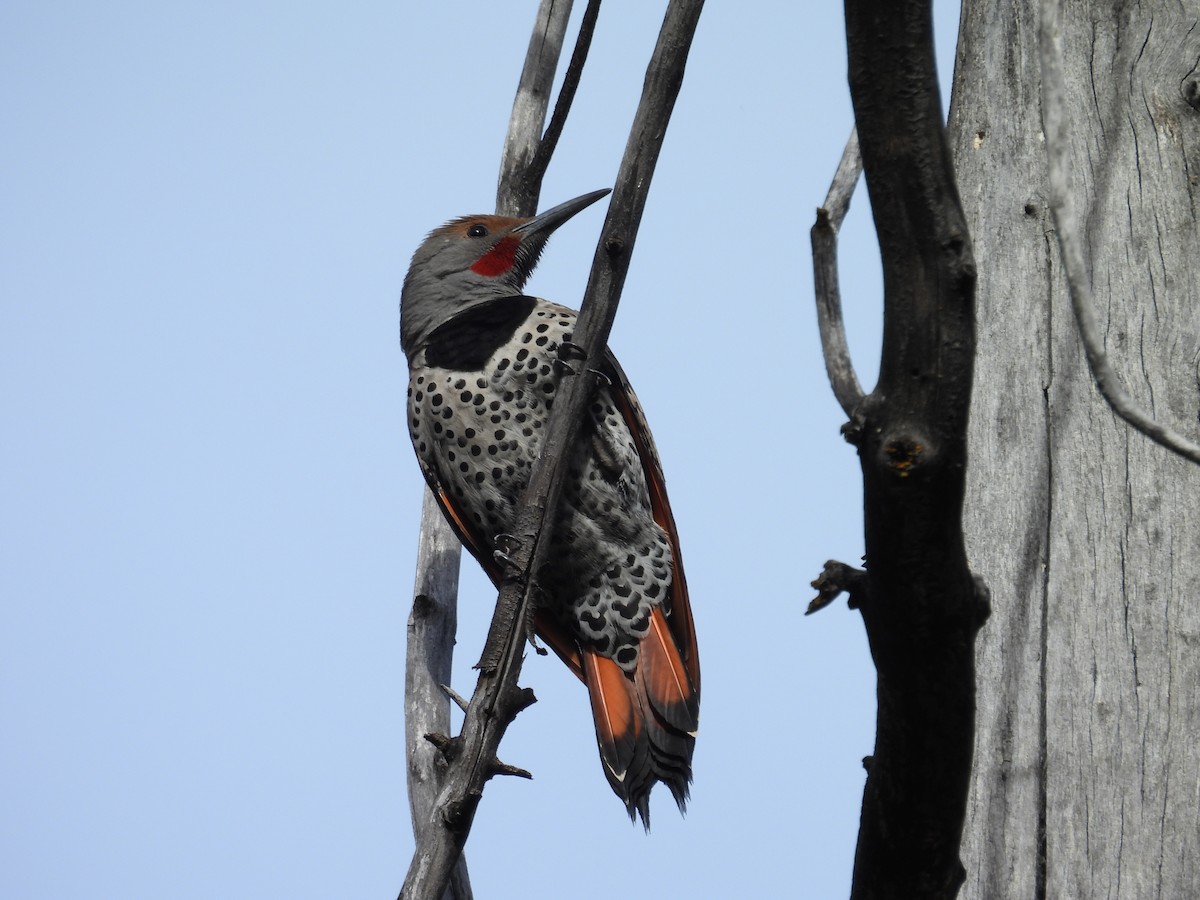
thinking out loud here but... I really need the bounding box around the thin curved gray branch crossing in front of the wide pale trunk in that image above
[1038,0,1200,463]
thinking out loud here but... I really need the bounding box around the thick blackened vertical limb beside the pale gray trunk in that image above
[846,0,988,899]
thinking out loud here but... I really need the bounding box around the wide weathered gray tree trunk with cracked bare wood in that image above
[950,0,1200,898]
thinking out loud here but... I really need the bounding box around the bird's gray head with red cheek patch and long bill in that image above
[400,188,608,355]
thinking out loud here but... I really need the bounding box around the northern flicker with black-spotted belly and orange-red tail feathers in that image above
[400,191,700,826]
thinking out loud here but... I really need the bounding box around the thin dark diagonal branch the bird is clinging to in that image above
[401,0,703,900]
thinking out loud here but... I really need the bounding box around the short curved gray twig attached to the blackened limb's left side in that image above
[809,128,863,420]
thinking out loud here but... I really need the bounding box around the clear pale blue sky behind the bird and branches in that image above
[0,0,956,900]
